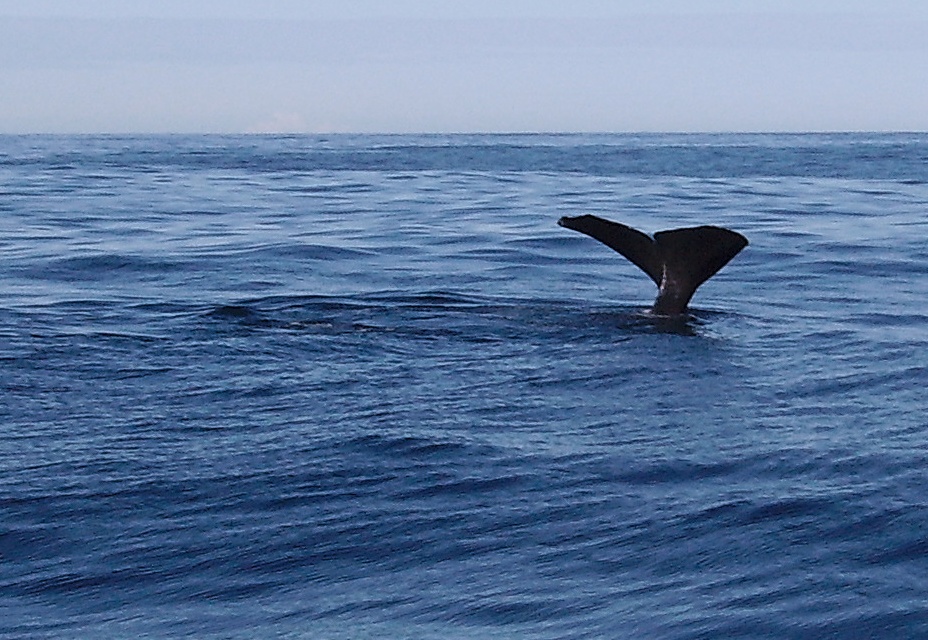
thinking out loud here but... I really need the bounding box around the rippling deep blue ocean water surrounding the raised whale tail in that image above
[0,134,928,640]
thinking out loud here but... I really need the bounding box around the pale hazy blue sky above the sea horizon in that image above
[0,0,928,133]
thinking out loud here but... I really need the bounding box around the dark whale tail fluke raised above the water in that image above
[557,215,748,316]
